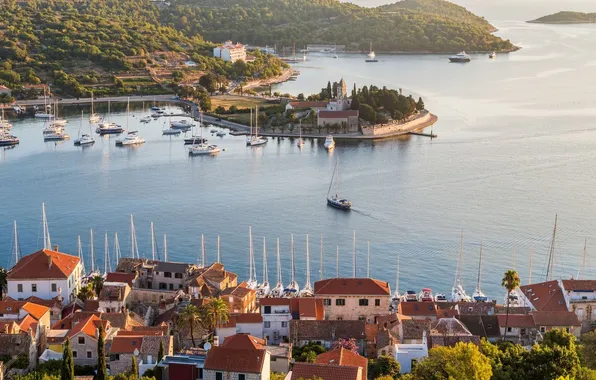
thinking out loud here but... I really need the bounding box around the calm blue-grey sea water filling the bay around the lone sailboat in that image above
[0,3,596,300]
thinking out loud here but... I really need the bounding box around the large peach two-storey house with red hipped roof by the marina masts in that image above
[315,278,391,323]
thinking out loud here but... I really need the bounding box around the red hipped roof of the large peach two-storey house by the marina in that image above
[315,278,390,296]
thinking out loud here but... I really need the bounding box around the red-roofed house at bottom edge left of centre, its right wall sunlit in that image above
[203,334,271,380]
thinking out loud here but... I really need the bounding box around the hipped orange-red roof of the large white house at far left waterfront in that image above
[8,249,80,280]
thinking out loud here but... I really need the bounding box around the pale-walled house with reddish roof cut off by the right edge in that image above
[562,279,596,332]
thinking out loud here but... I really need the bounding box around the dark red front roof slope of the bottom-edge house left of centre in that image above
[203,346,267,374]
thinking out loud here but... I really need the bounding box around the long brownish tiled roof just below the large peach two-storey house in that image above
[290,320,366,341]
